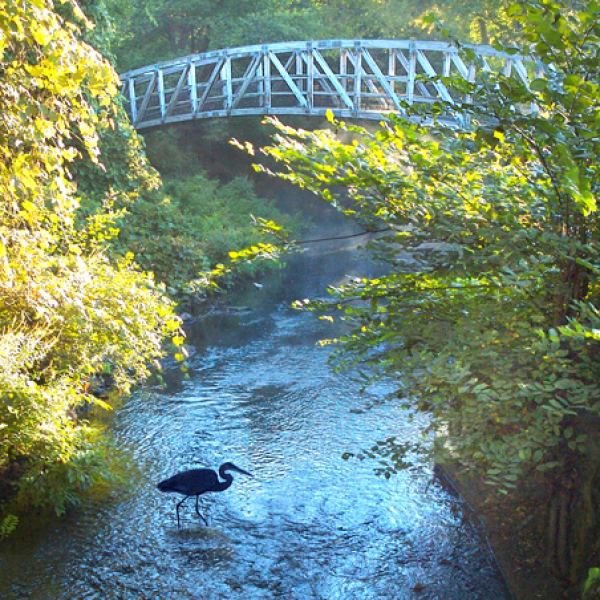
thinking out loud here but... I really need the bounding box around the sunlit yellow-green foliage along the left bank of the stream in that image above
[0,0,182,513]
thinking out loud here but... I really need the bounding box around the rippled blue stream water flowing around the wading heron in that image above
[0,254,509,600]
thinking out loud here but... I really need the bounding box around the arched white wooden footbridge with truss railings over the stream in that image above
[121,40,541,130]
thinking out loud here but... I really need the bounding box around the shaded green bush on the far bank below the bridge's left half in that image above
[106,173,297,297]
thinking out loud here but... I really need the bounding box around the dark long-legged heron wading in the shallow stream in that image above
[156,462,252,529]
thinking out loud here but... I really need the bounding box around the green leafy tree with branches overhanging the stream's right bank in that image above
[252,0,600,582]
